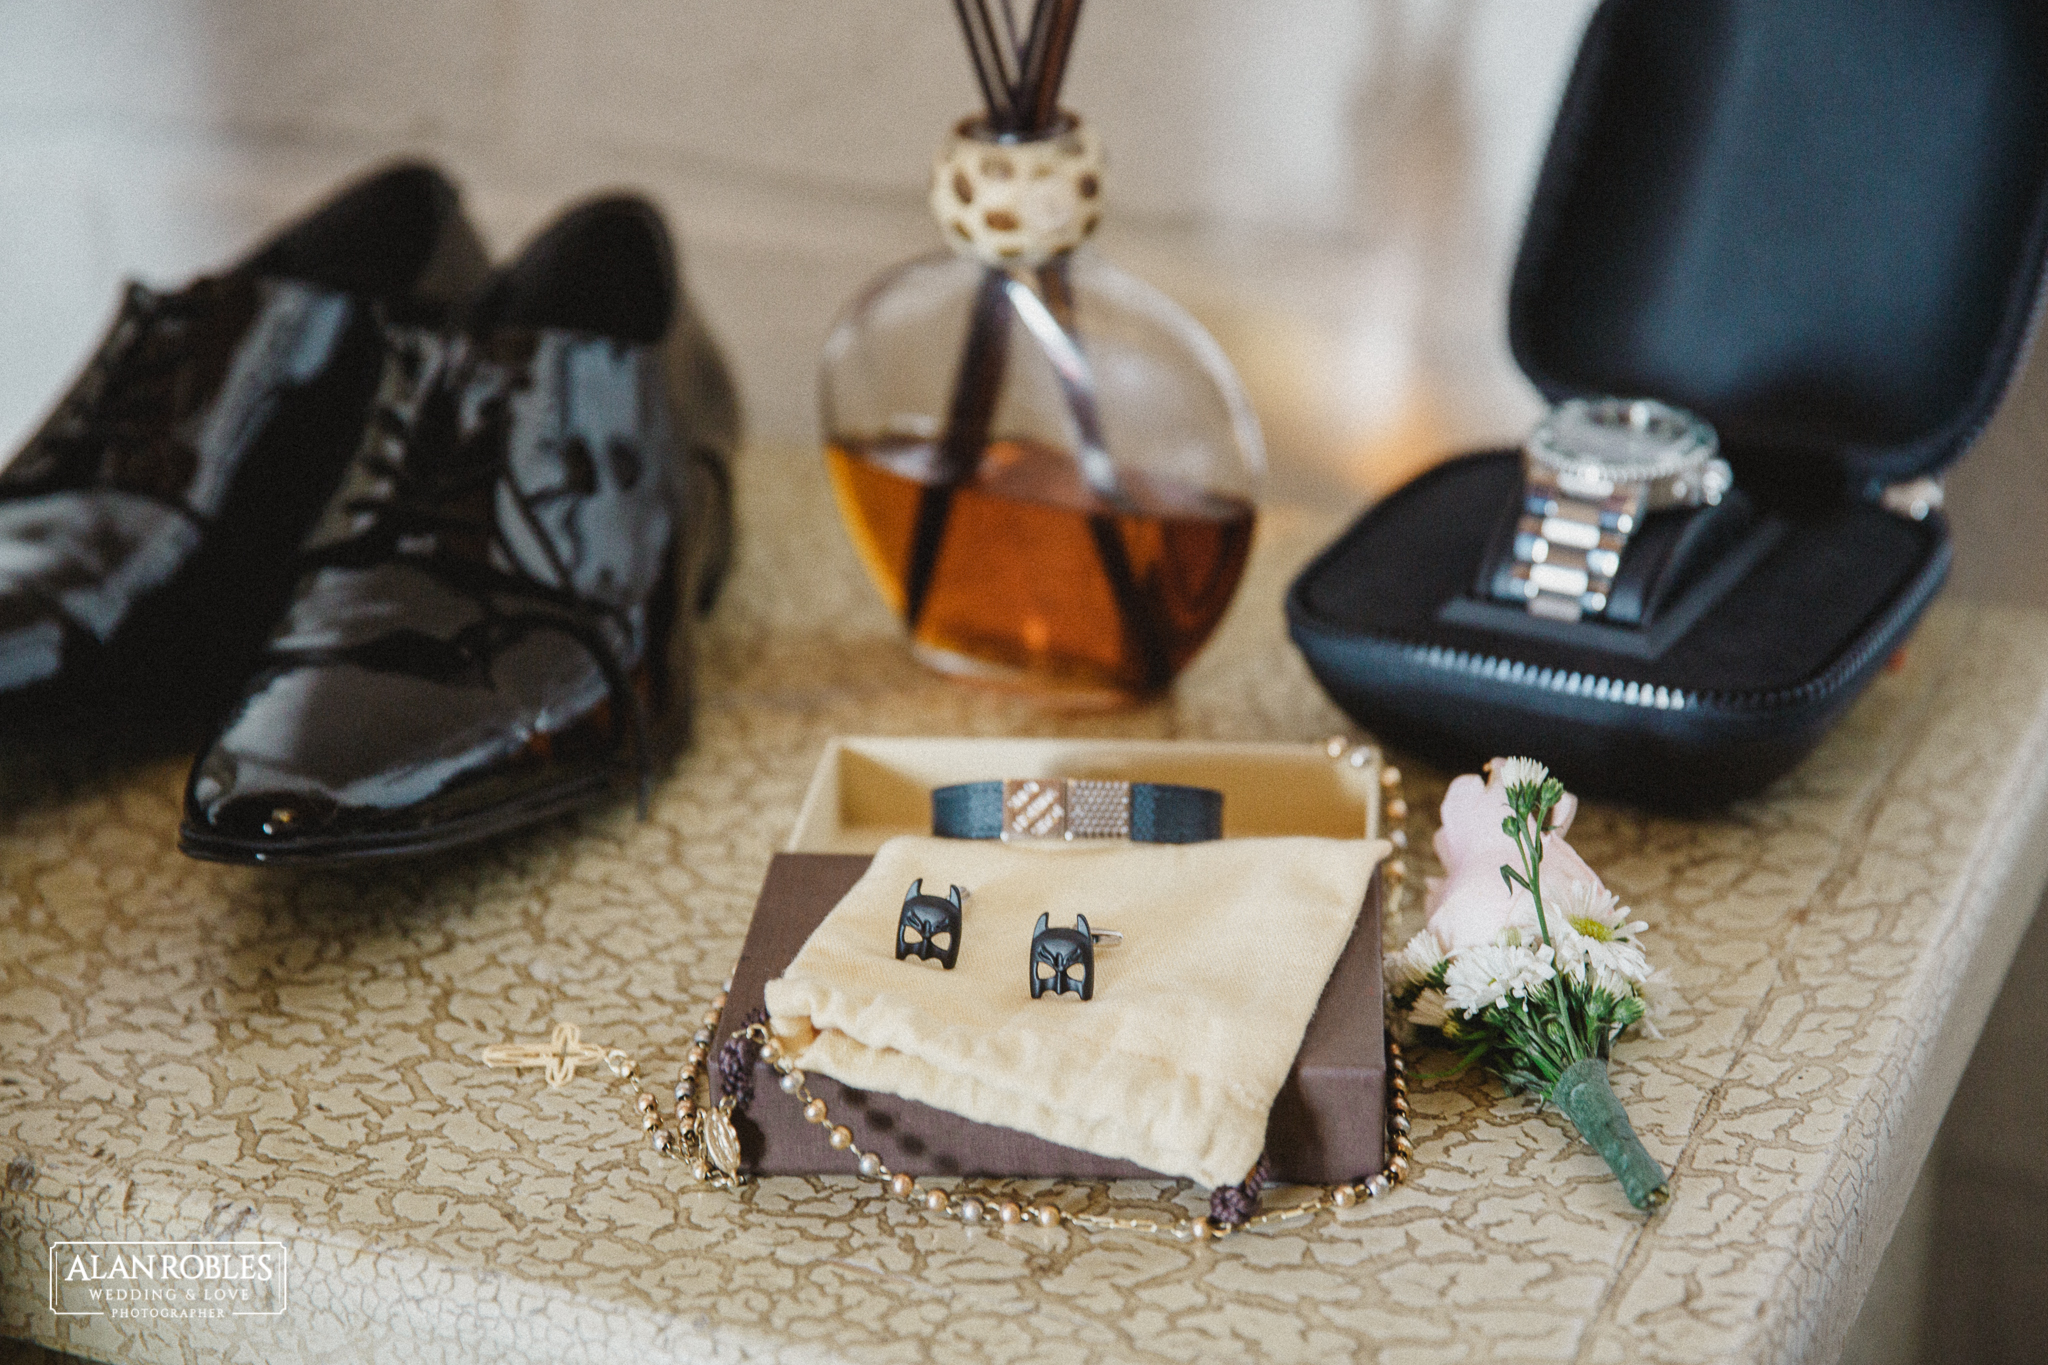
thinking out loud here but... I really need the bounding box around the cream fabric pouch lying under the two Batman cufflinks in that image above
[766,837,1389,1185]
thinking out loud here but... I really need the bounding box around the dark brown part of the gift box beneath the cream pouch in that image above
[713,853,1386,1185]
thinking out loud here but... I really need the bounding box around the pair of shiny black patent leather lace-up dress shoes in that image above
[0,164,739,864]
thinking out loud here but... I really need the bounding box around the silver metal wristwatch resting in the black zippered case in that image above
[1497,399,1733,620]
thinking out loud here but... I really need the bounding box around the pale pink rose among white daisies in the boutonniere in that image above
[1425,759,1602,952]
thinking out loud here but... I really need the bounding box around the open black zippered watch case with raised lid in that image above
[1286,0,2048,806]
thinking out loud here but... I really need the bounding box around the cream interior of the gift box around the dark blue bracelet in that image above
[782,737,1380,853]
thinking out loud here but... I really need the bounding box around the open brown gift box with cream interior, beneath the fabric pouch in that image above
[713,739,1386,1183]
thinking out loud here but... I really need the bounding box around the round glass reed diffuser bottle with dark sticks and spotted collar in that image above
[821,0,1264,704]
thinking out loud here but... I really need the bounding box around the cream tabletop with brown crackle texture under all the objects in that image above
[0,450,2048,1365]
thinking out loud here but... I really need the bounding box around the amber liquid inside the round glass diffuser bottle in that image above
[825,440,1253,700]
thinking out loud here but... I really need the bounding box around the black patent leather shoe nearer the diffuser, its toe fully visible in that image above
[180,199,737,864]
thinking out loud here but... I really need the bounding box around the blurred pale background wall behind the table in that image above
[0,0,2048,1363]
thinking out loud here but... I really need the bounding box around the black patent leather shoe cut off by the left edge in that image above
[0,164,487,743]
